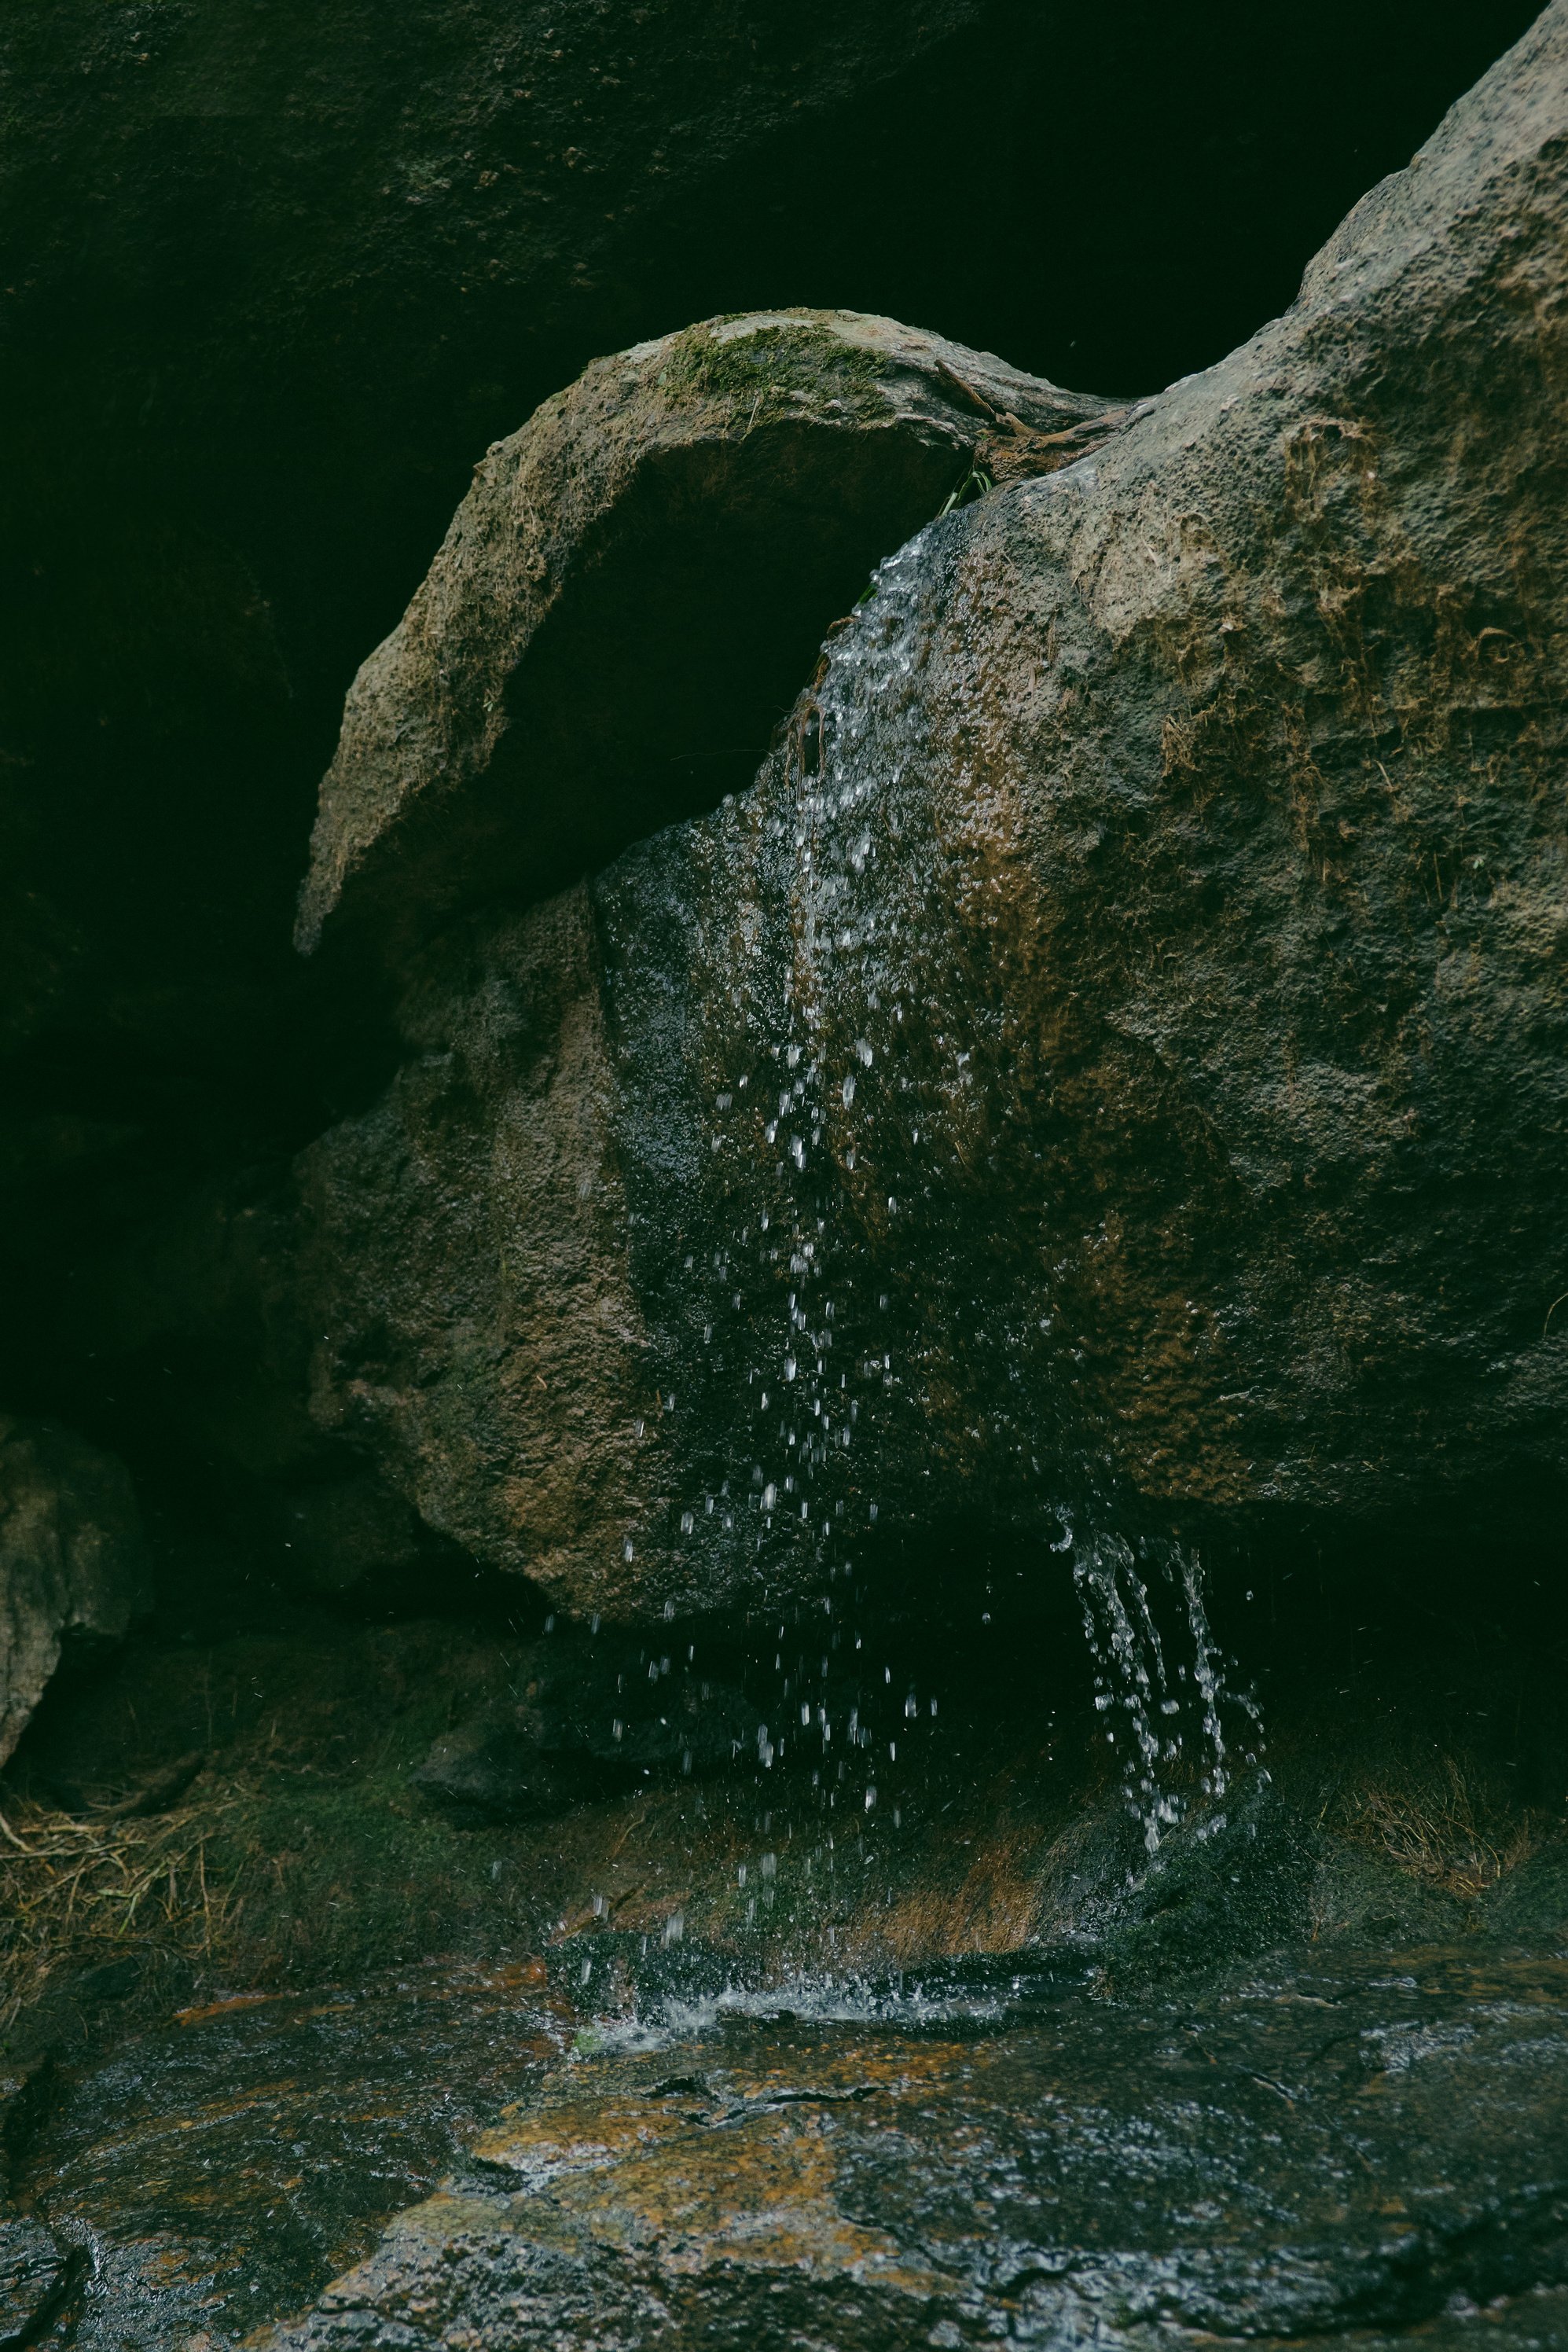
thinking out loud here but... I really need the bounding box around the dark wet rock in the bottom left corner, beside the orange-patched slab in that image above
[10,1966,560,2352]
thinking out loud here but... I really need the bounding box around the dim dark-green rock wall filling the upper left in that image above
[0,0,1006,1418]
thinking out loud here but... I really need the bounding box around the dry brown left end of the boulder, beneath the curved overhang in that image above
[301,891,652,1604]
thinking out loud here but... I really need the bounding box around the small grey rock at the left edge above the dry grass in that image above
[0,1413,150,1764]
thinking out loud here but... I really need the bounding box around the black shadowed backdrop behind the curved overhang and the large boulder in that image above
[0,0,1530,1523]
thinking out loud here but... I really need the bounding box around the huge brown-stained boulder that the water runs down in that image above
[303,5,1568,1614]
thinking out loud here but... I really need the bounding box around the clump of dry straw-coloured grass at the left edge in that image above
[0,1790,240,2030]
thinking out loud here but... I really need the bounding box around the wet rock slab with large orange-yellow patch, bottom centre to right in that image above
[257,1952,1568,2347]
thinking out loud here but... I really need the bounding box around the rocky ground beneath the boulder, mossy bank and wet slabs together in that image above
[0,1495,1568,2352]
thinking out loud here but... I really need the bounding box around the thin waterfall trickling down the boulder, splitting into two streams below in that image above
[630,510,1260,1849]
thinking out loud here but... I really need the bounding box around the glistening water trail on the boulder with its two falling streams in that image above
[681,515,1255,1851]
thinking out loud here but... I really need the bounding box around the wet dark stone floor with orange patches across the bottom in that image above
[0,1938,1568,2352]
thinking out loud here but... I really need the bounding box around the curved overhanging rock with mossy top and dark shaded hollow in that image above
[299,311,1110,948]
